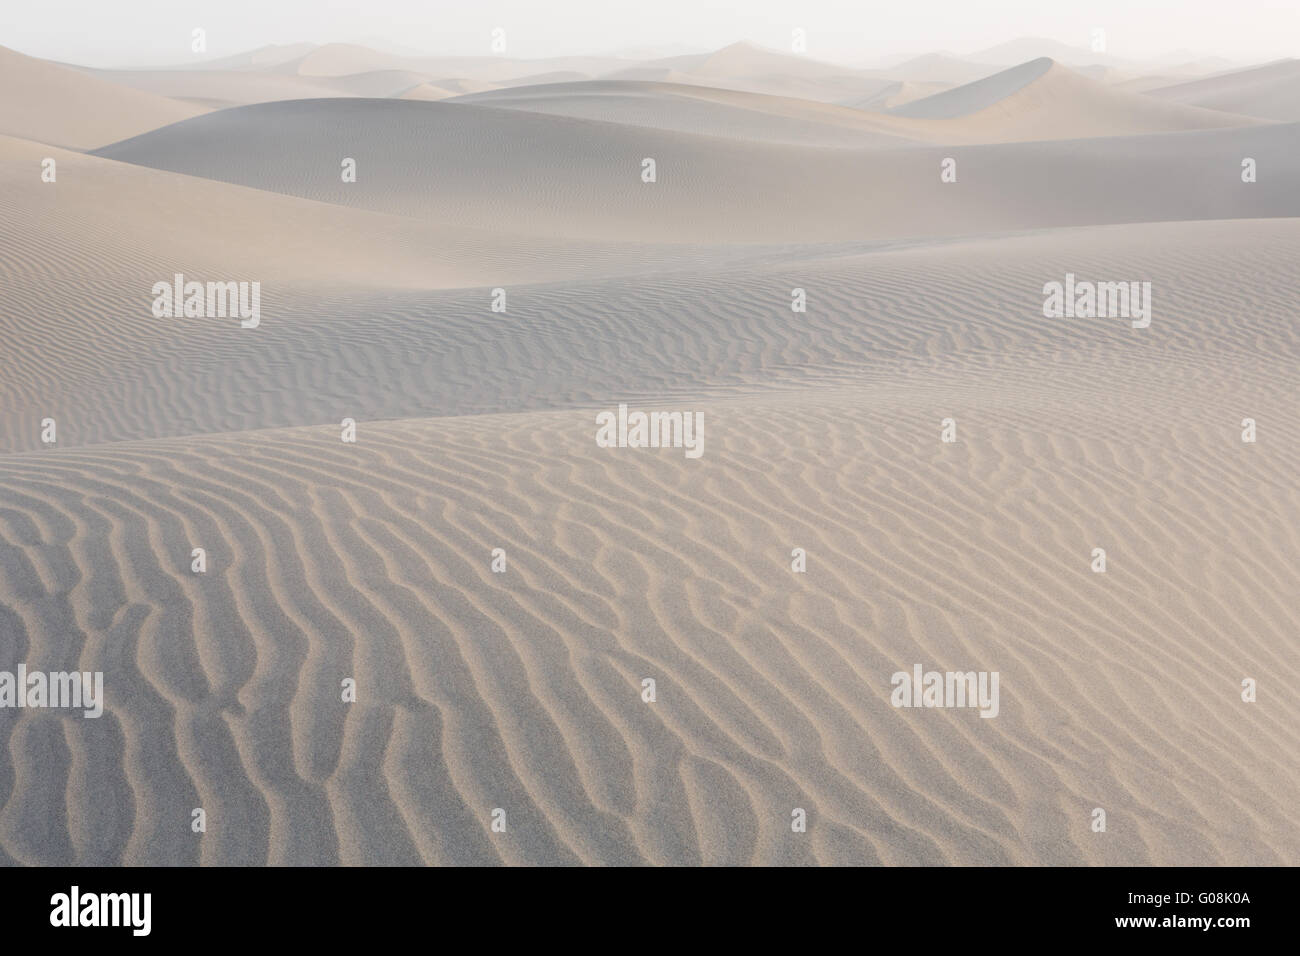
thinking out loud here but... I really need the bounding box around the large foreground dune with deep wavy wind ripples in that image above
[0,390,1300,864]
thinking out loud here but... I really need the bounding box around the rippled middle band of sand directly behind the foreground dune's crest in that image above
[0,204,1300,451]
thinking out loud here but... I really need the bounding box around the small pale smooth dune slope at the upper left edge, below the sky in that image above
[0,47,205,150]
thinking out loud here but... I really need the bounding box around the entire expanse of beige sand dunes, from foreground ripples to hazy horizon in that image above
[0,35,1300,865]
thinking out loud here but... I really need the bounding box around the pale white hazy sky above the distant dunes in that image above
[10,0,1300,65]
